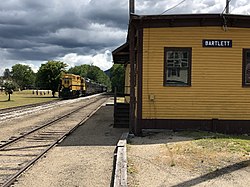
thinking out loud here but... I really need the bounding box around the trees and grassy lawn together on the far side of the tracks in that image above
[0,60,124,108]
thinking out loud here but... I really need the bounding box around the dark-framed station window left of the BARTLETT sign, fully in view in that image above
[164,47,192,86]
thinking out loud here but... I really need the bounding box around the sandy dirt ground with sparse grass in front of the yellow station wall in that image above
[127,131,250,187]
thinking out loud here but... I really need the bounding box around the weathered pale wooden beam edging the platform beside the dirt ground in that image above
[112,132,129,187]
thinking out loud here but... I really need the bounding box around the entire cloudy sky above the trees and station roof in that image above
[0,0,250,75]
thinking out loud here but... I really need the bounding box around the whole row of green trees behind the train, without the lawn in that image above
[0,61,124,99]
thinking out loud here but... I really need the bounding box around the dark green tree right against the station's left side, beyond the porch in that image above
[110,64,125,93]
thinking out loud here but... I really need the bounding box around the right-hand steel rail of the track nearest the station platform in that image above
[1,96,107,187]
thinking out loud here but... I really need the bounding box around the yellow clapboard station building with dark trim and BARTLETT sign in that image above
[113,14,250,134]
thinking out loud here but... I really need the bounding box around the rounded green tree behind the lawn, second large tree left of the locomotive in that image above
[11,64,35,90]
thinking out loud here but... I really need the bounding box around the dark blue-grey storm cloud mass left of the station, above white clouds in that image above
[0,0,127,66]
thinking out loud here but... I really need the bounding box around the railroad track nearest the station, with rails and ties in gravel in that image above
[0,96,107,187]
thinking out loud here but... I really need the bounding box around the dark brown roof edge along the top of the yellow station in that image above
[131,14,250,28]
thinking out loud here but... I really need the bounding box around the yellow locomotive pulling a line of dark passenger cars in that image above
[59,74,107,99]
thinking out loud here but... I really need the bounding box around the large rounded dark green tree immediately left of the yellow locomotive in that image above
[36,61,67,97]
